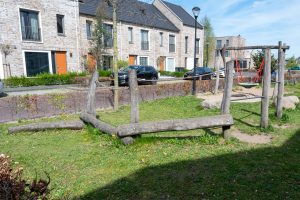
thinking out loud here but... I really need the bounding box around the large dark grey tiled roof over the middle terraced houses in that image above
[79,0,180,32]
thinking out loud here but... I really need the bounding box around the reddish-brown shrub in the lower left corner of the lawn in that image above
[0,154,50,199]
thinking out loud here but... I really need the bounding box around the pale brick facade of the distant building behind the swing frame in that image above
[214,35,253,68]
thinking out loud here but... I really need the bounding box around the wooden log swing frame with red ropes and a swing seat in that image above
[217,41,290,128]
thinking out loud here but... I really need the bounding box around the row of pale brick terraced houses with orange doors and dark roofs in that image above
[0,0,204,78]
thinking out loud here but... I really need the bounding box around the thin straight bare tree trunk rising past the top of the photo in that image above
[111,0,119,111]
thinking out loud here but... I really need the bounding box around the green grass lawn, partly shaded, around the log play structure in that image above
[0,84,300,199]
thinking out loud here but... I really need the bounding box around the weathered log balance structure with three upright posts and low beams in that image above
[80,70,233,144]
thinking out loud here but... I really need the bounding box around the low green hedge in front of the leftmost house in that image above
[4,72,86,87]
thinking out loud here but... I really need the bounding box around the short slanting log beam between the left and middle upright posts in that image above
[80,113,117,135]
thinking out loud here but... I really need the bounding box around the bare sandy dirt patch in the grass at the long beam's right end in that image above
[230,130,272,144]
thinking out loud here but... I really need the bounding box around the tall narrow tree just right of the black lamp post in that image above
[201,16,216,66]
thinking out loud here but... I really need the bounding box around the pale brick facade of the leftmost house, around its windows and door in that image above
[0,0,81,78]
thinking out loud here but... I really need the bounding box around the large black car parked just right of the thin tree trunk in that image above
[113,65,158,85]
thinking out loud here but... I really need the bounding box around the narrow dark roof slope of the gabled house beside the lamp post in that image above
[163,1,203,29]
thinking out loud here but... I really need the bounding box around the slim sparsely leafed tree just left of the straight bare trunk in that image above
[89,2,107,70]
